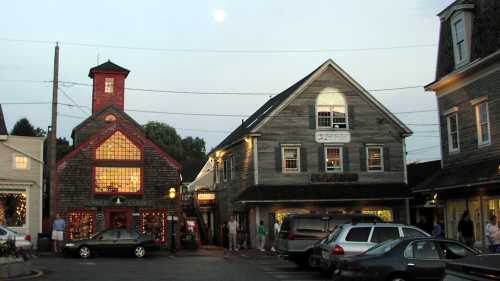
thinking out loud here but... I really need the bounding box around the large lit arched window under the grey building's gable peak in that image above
[316,88,348,129]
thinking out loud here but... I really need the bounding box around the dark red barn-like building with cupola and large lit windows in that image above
[55,61,181,243]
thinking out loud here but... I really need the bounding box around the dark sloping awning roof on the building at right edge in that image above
[413,156,500,192]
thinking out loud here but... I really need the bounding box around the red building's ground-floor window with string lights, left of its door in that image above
[68,211,95,240]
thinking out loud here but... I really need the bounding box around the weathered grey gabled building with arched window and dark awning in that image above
[205,60,411,245]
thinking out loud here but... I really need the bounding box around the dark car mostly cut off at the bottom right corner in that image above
[443,254,500,281]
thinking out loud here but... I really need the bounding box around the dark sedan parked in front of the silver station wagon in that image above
[334,238,480,281]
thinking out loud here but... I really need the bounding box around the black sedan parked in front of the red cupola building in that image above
[62,229,158,258]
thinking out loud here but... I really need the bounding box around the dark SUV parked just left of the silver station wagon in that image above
[277,214,382,267]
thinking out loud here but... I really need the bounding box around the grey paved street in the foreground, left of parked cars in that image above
[35,251,332,281]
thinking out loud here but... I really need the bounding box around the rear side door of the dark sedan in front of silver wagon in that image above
[404,240,445,281]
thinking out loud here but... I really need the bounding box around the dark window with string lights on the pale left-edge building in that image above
[0,192,26,227]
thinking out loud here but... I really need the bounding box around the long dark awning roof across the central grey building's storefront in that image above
[235,183,411,203]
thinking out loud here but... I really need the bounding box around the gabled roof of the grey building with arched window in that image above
[209,59,412,154]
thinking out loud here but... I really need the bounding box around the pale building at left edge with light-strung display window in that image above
[0,106,44,248]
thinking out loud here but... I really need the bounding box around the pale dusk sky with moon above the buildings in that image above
[0,0,452,161]
